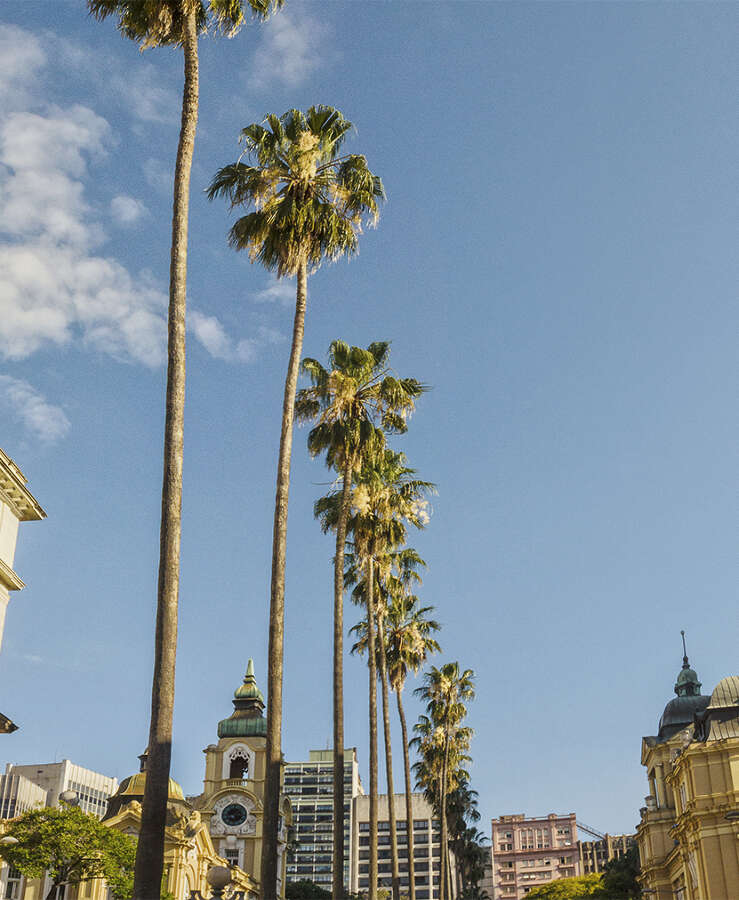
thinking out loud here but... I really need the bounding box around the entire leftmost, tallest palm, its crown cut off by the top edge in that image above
[87,0,283,897]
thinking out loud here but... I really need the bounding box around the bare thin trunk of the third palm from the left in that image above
[331,460,353,900]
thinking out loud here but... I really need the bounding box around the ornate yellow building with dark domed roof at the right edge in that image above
[637,655,739,900]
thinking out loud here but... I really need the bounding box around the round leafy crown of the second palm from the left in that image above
[208,106,385,276]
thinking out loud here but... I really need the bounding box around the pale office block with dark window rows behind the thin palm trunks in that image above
[351,794,456,900]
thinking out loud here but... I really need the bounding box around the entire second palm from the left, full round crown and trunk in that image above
[208,112,384,896]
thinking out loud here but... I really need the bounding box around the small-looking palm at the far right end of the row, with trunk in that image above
[416,662,475,897]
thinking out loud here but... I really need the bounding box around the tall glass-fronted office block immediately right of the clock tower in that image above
[284,747,364,888]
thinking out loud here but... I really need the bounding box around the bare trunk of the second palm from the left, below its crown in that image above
[260,261,308,900]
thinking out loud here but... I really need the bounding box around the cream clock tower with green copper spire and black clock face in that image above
[195,659,291,898]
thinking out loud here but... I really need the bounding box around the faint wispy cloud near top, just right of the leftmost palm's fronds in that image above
[249,10,328,89]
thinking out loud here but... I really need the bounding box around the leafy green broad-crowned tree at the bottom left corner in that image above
[0,807,136,900]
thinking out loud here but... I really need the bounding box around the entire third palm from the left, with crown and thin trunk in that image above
[295,341,426,898]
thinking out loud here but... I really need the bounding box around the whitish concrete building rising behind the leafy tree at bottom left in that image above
[2,759,118,819]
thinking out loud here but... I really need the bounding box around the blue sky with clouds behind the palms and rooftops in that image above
[0,0,739,833]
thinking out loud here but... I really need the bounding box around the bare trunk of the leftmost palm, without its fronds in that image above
[133,11,199,900]
